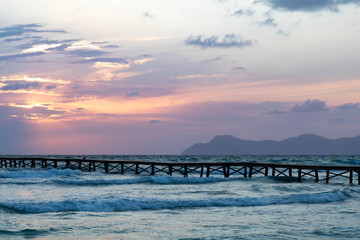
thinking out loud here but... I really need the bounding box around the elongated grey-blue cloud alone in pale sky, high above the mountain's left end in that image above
[185,34,253,49]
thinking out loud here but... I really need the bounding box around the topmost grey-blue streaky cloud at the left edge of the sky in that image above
[0,24,66,38]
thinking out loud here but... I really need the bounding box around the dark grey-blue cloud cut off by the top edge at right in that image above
[258,0,360,12]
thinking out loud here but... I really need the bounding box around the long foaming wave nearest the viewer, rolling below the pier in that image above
[0,189,359,213]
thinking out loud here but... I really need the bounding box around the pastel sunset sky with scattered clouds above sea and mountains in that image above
[0,0,360,154]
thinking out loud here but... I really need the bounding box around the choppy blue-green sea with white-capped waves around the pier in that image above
[0,155,360,240]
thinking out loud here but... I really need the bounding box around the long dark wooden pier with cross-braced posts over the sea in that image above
[0,158,360,184]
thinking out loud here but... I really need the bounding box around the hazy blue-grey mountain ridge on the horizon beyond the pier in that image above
[182,134,360,155]
